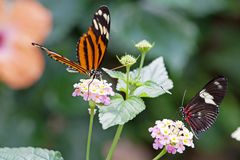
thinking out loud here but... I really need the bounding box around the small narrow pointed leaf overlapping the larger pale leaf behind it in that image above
[133,81,171,98]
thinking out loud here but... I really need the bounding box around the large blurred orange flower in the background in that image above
[0,0,52,89]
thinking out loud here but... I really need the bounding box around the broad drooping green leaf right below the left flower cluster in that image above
[99,94,146,129]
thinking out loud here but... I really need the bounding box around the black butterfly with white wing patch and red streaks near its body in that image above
[181,76,227,138]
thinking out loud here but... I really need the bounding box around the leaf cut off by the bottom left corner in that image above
[0,147,63,160]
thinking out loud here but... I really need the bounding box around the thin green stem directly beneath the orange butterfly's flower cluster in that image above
[86,101,95,160]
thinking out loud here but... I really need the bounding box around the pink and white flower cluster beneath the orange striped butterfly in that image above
[72,79,114,105]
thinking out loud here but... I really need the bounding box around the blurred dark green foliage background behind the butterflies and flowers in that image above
[0,0,240,160]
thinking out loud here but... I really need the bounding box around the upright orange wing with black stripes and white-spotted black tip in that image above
[77,6,110,71]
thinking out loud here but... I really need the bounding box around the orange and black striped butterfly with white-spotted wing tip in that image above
[32,6,110,78]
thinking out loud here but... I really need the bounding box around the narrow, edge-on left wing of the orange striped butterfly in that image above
[32,43,88,74]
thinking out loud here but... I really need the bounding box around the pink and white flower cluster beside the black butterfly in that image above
[149,119,194,154]
